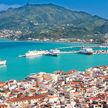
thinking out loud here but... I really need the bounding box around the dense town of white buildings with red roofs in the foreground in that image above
[0,66,108,108]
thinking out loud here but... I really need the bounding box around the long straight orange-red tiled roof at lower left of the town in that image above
[8,92,49,102]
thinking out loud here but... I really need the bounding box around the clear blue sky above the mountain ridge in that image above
[0,0,108,19]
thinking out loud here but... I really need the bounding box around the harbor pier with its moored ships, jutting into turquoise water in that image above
[18,46,108,57]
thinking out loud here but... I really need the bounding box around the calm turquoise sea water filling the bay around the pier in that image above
[0,39,108,81]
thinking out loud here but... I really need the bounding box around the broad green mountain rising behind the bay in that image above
[0,4,108,42]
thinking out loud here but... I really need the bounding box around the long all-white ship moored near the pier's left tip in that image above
[25,50,46,57]
